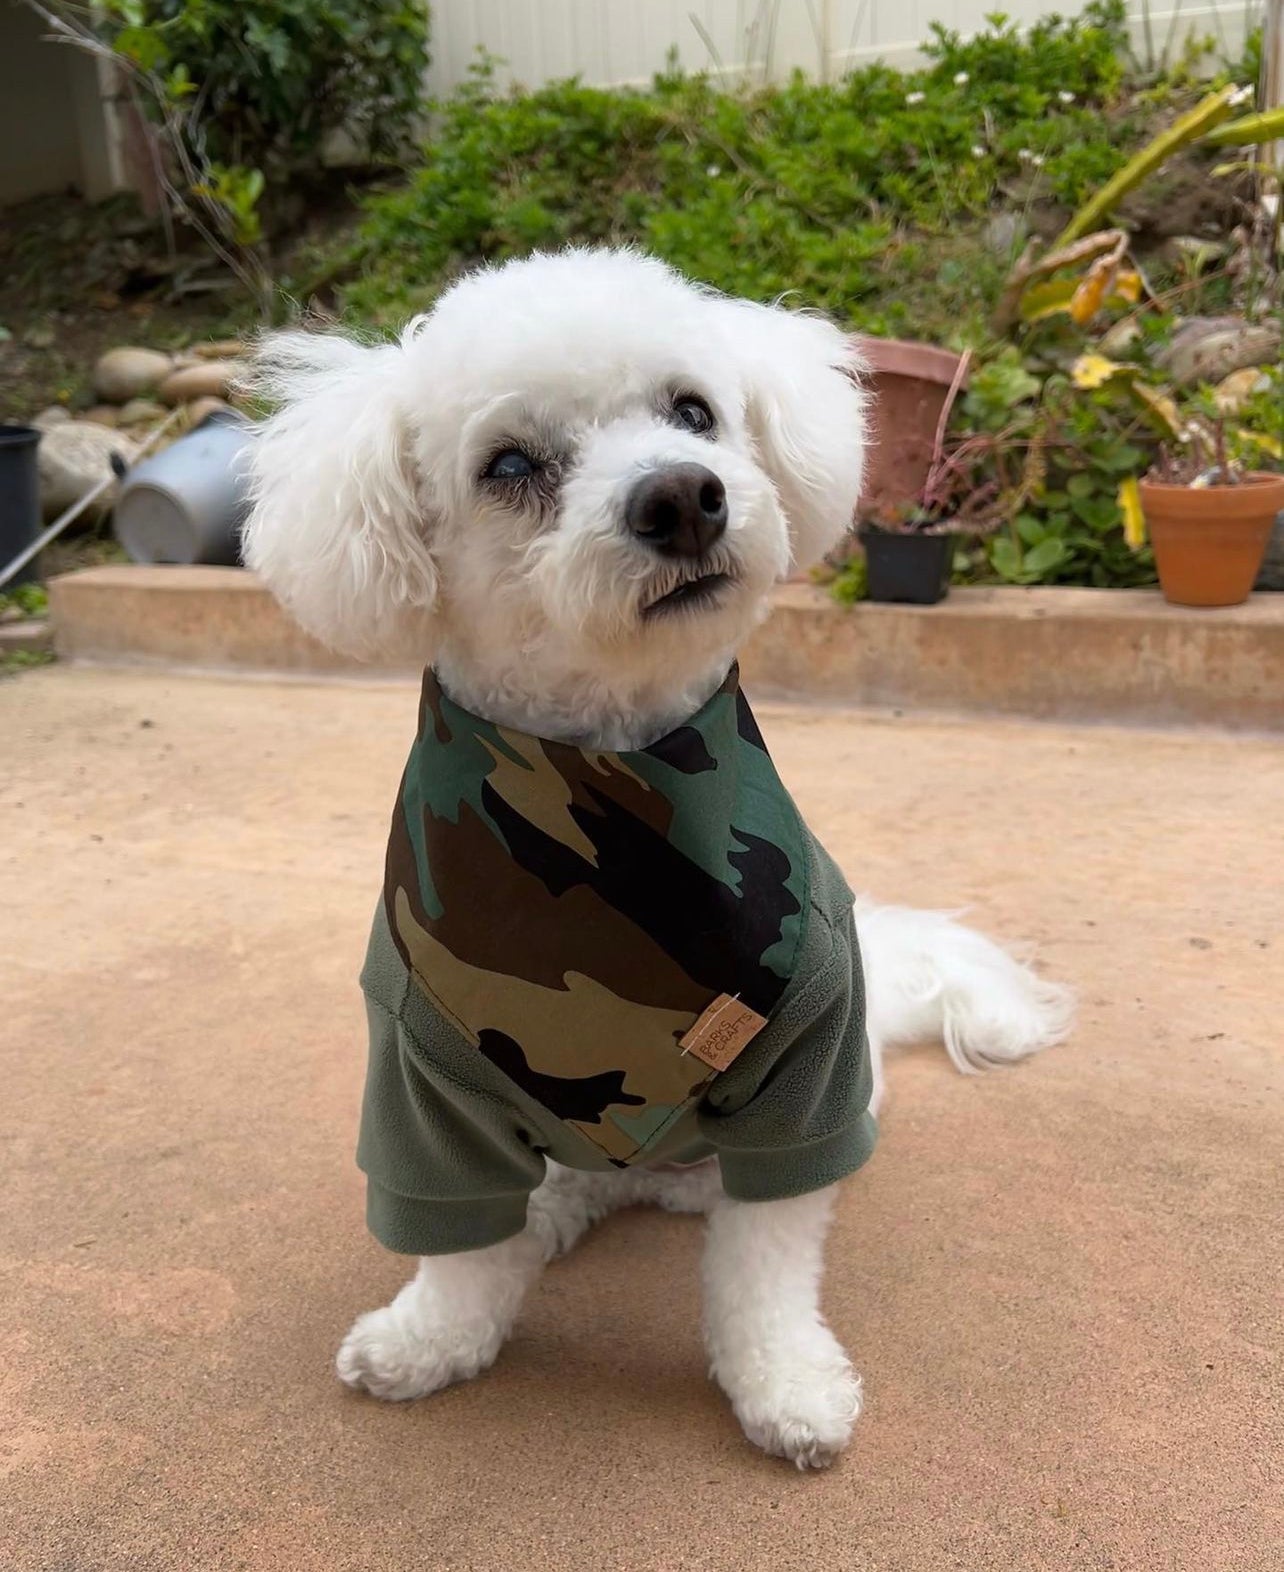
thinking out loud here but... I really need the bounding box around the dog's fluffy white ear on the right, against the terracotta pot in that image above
[725,300,868,569]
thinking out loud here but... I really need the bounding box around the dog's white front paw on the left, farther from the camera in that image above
[335,1302,503,1402]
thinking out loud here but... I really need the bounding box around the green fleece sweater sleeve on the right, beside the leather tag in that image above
[699,909,875,1201]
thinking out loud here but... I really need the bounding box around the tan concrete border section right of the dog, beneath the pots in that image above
[742,585,1284,731]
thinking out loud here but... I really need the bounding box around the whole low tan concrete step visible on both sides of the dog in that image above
[49,566,1284,731]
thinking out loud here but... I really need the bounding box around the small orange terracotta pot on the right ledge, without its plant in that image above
[1141,472,1284,605]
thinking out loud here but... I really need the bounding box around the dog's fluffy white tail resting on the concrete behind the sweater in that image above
[855,899,1075,1089]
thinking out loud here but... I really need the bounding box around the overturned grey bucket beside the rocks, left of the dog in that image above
[112,410,255,564]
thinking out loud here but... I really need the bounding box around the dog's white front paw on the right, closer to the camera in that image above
[725,1331,861,1468]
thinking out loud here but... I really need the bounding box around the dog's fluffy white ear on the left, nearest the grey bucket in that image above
[242,332,437,662]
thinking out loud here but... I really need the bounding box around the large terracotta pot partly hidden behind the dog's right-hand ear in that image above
[857,338,959,519]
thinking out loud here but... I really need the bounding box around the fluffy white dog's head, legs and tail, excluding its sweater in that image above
[245,252,1070,1468]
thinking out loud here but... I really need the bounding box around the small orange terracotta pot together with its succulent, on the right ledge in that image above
[1138,420,1284,605]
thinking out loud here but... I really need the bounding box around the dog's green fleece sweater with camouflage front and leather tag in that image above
[358,668,874,1254]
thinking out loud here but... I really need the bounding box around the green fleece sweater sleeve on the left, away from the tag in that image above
[357,995,544,1256]
